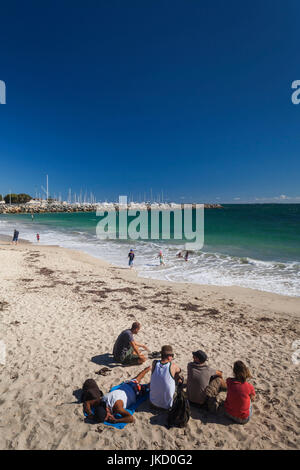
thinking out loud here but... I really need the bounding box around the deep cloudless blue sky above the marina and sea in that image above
[0,0,300,202]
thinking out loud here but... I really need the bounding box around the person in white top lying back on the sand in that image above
[83,366,151,423]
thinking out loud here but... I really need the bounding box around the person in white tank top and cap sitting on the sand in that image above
[150,345,182,410]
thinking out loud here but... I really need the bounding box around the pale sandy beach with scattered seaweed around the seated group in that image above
[0,241,300,450]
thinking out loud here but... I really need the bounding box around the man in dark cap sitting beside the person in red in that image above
[187,350,227,412]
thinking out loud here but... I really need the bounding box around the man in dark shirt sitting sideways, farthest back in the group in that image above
[113,322,149,364]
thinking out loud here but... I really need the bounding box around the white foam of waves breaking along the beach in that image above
[0,220,300,296]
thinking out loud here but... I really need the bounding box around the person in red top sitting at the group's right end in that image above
[224,361,255,424]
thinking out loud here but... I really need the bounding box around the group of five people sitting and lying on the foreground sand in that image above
[82,322,255,424]
